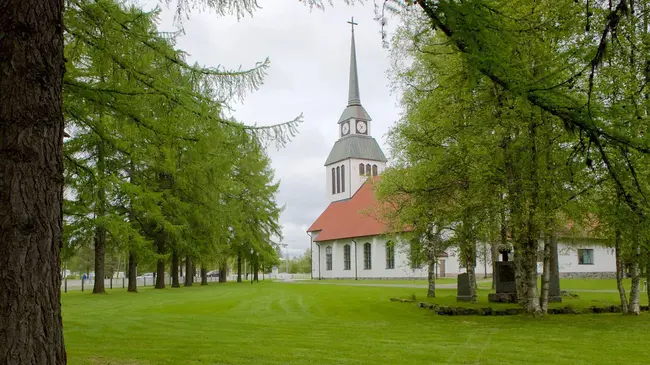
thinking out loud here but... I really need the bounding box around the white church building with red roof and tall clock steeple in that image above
[307,24,616,279]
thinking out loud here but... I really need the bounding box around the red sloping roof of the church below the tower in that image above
[307,178,388,242]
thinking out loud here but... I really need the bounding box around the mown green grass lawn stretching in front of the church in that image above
[62,282,650,365]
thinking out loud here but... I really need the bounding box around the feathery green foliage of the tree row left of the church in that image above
[62,0,292,282]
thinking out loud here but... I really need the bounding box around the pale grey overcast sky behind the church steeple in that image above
[144,0,399,256]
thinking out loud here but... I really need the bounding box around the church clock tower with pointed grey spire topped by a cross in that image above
[325,18,387,202]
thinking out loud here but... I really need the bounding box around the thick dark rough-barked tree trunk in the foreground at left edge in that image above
[0,0,66,365]
